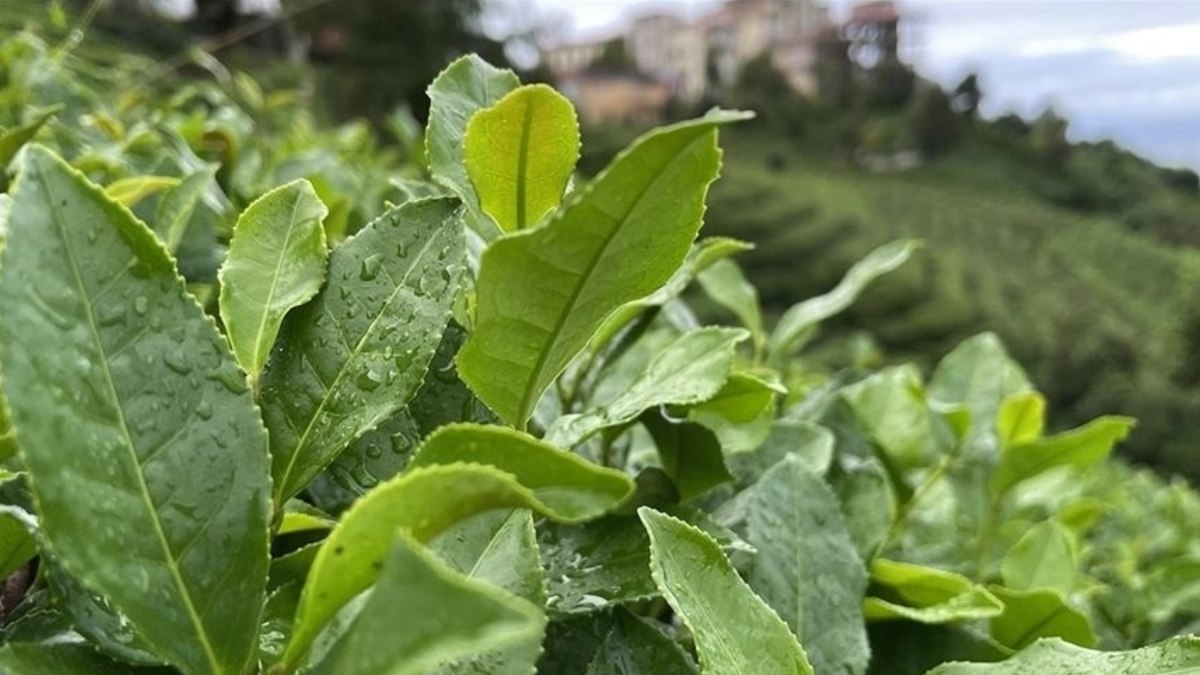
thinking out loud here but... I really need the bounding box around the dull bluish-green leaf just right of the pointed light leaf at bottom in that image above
[746,456,871,674]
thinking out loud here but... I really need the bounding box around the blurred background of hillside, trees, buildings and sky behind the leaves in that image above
[7,0,1200,479]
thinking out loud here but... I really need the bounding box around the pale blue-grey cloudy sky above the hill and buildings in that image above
[536,0,1200,168]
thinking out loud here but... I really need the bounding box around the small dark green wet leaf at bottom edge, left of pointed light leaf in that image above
[587,609,700,675]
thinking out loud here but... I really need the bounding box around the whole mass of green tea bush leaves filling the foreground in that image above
[0,30,1200,675]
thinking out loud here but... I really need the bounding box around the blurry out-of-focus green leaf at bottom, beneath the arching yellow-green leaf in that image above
[312,534,546,675]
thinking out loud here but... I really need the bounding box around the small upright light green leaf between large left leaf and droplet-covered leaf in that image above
[218,180,329,389]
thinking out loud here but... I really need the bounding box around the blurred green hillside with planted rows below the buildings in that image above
[707,124,1200,477]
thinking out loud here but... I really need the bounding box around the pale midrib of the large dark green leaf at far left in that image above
[37,167,223,673]
